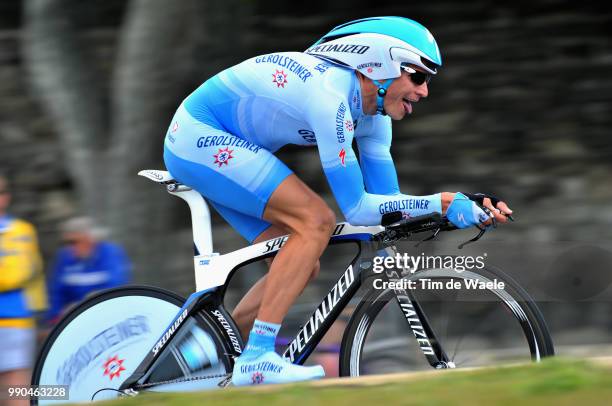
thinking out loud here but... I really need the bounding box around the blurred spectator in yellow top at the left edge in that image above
[0,173,46,404]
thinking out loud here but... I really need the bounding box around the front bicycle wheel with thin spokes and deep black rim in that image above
[340,268,554,376]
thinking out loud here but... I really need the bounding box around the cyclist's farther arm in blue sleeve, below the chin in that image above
[355,115,400,195]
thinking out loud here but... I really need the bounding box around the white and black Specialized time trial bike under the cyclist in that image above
[32,170,554,404]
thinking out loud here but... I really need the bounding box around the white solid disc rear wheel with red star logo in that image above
[32,286,229,405]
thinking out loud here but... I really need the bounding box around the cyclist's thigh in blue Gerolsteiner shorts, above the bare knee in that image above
[164,106,292,238]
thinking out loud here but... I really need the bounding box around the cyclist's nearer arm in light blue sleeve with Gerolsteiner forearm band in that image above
[306,94,441,225]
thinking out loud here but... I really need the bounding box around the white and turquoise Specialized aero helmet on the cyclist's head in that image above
[305,17,442,113]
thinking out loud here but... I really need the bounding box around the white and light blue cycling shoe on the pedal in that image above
[232,351,325,386]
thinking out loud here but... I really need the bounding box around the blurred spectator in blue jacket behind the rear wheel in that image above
[48,217,131,324]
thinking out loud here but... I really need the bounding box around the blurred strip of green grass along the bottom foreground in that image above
[94,359,612,406]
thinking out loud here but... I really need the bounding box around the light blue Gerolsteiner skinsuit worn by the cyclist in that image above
[164,52,441,241]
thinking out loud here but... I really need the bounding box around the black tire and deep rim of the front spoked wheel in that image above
[339,267,554,376]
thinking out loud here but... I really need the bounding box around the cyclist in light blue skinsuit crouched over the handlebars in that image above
[164,17,511,385]
